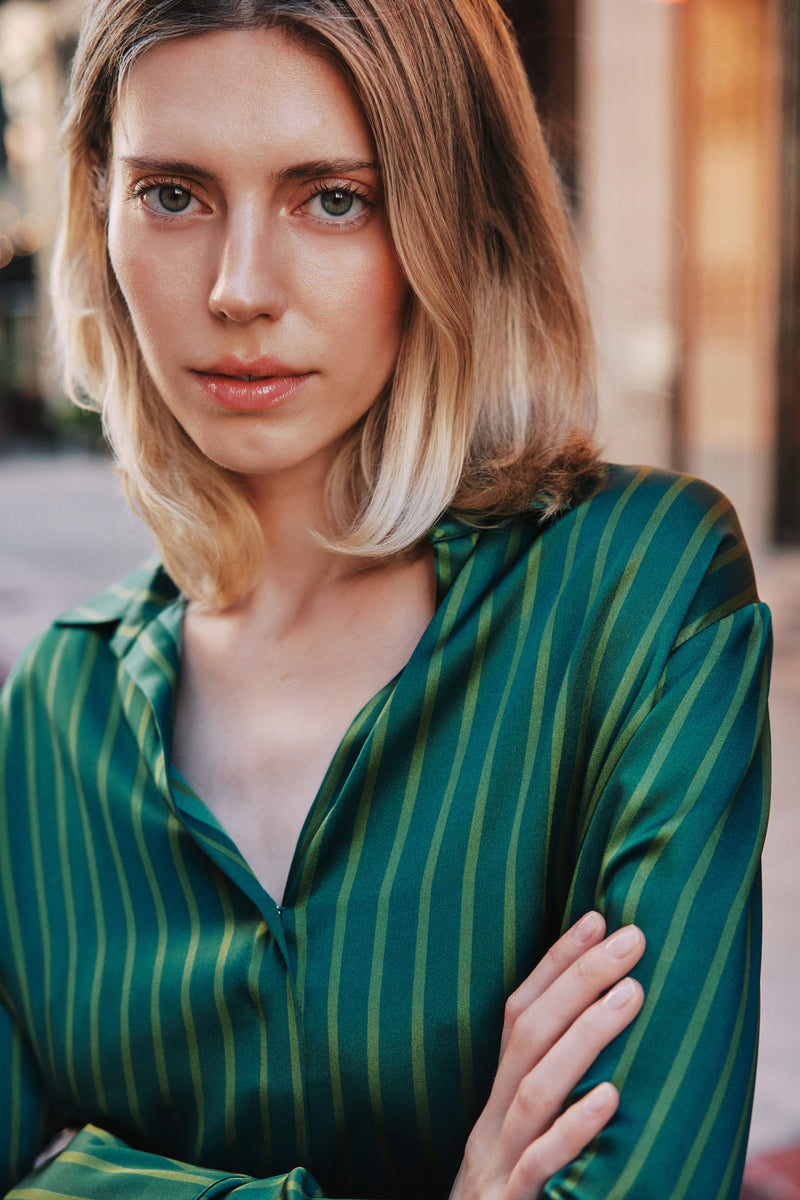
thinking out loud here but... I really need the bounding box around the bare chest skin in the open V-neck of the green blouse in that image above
[173,554,435,902]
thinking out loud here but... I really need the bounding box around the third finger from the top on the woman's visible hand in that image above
[500,979,644,1164]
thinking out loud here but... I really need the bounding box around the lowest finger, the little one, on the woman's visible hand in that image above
[503,1084,619,1200]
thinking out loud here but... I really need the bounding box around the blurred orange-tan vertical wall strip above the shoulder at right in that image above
[678,0,781,549]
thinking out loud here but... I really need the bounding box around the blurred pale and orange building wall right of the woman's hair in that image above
[578,0,781,546]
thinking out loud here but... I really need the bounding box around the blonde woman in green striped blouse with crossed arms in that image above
[0,0,769,1200]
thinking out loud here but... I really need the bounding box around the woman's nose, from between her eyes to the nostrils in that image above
[209,205,287,323]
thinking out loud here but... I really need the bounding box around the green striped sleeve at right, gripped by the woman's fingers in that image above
[545,597,769,1200]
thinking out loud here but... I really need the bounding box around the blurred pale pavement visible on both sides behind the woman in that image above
[0,452,800,1200]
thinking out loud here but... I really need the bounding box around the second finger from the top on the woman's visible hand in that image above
[489,925,645,1114]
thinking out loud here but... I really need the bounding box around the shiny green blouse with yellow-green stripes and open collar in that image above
[0,467,769,1200]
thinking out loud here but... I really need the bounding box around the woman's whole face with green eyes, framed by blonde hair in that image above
[108,30,407,492]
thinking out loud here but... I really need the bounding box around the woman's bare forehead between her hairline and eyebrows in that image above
[113,29,373,165]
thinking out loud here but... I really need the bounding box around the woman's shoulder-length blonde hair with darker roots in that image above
[53,0,595,607]
